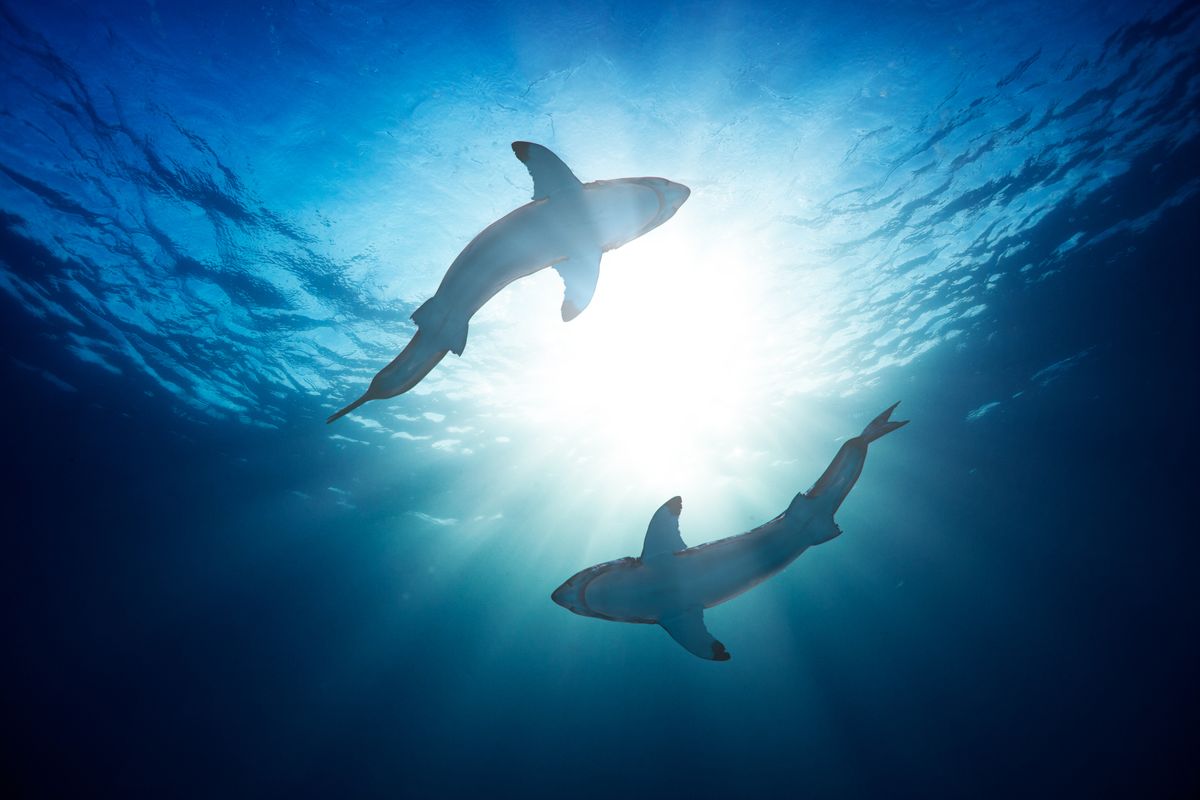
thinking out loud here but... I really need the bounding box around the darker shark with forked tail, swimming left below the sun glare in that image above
[551,403,908,661]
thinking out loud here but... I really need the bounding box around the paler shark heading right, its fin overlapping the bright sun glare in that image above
[325,142,691,423]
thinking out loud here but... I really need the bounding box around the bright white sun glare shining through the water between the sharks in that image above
[513,219,772,480]
